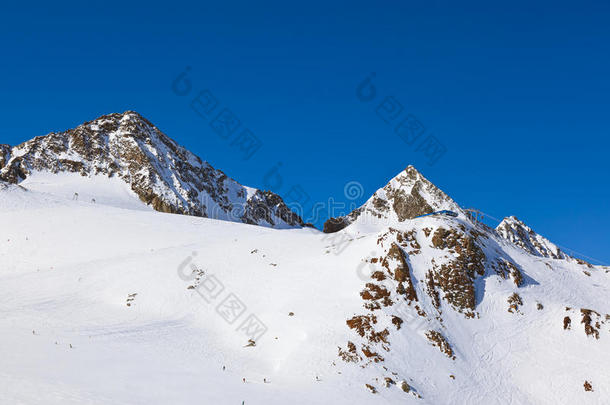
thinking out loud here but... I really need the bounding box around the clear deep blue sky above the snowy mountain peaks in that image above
[0,1,610,262]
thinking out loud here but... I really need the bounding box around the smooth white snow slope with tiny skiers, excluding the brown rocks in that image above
[0,181,610,405]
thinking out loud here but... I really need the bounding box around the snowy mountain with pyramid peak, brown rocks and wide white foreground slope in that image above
[0,145,610,405]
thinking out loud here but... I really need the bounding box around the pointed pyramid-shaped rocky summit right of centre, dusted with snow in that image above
[324,166,463,233]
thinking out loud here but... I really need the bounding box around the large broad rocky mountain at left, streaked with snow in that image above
[0,111,304,227]
